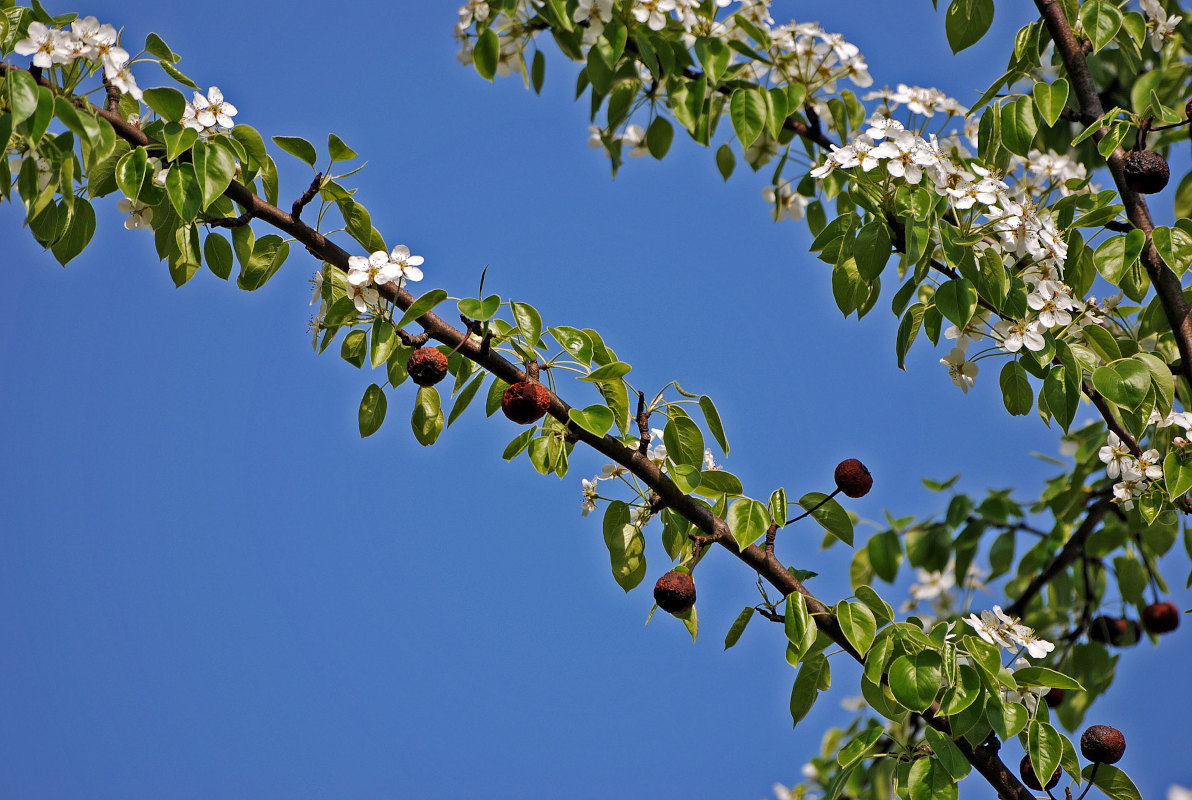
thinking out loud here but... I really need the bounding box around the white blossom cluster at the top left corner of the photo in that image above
[13,17,141,100]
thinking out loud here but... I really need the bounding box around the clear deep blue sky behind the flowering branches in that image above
[0,0,1192,799]
